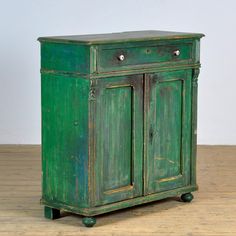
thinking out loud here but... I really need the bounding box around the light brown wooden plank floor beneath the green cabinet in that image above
[0,145,236,236]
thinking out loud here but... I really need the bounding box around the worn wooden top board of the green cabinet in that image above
[38,30,204,44]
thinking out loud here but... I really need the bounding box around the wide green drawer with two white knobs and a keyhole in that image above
[97,43,193,72]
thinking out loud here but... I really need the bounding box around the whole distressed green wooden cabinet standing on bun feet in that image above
[39,31,203,227]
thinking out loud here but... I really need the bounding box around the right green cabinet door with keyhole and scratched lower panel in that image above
[144,70,192,194]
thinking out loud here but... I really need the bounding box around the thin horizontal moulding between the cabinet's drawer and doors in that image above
[40,63,201,80]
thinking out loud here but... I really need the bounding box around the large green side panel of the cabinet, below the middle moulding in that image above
[41,74,89,207]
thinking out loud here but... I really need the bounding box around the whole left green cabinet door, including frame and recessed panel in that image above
[94,75,143,206]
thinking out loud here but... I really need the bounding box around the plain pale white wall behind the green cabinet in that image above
[0,0,236,144]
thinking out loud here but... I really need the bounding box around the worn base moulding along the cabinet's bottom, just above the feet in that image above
[40,185,198,216]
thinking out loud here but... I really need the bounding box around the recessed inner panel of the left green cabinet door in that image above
[101,86,133,191]
